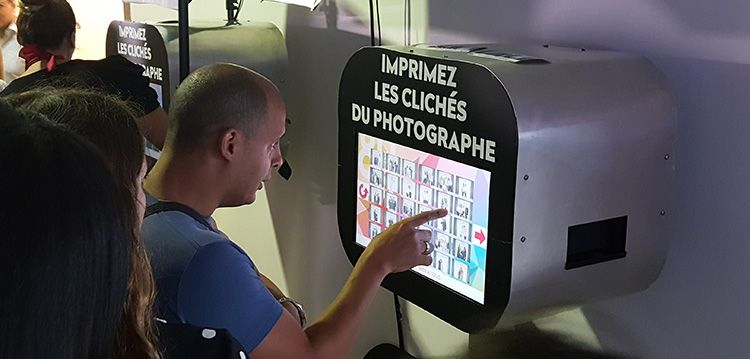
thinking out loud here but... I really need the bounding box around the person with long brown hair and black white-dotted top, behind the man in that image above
[5,88,244,359]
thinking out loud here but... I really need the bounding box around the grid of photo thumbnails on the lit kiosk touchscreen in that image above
[369,149,474,283]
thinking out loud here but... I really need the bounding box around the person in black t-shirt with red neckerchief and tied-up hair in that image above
[0,0,167,148]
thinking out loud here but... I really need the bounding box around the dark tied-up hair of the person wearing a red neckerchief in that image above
[16,0,77,49]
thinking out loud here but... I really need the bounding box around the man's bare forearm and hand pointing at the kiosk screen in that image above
[252,209,447,358]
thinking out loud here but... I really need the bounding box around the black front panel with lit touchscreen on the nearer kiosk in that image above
[338,47,518,332]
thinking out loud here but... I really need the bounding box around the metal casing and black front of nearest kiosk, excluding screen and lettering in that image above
[338,44,676,333]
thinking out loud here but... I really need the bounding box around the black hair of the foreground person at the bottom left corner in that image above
[0,99,134,358]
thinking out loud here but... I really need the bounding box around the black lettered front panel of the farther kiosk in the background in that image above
[106,21,171,108]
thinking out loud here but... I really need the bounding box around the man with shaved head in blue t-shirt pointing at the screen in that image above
[142,64,447,358]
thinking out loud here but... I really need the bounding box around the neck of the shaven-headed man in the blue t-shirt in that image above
[143,151,221,217]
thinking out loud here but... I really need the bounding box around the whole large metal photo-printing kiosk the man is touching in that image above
[338,45,675,333]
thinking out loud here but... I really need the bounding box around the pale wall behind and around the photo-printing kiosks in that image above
[134,0,750,358]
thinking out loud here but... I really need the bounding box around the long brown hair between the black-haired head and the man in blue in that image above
[7,88,159,358]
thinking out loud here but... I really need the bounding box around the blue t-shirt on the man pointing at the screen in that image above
[141,196,283,352]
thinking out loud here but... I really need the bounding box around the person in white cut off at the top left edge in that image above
[0,0,25,82]
